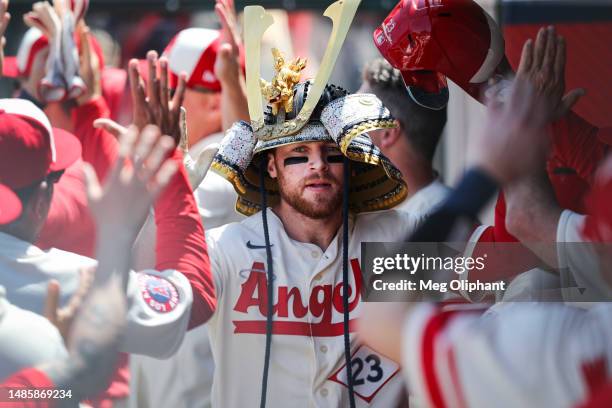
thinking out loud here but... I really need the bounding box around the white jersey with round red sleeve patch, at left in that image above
[0,232,193,358]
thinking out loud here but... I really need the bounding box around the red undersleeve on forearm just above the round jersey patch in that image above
[155,151,216,328]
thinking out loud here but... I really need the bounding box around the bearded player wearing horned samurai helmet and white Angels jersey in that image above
[200,1,426,407]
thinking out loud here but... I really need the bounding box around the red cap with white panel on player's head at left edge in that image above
[0,99,81,202]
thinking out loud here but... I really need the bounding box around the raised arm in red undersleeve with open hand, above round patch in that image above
[98,52,216,328]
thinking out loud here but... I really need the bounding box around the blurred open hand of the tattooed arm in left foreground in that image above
[85,125,177,238]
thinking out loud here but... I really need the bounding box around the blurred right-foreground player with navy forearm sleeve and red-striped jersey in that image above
[360,75,612,407]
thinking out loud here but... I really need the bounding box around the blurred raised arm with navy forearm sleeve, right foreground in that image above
[358,78,547,361]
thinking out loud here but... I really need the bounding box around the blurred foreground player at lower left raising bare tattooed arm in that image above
[0,116,185,405]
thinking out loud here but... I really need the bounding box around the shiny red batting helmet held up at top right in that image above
[374,0,504,98]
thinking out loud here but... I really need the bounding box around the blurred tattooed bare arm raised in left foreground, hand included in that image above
[29,127,177,400]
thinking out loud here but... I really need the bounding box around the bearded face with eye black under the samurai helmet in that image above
[268,142,343,219]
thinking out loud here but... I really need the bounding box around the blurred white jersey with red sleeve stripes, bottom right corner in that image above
[402,303,612,408]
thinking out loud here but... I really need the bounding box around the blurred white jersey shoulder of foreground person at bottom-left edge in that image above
[0,286,68,382]
